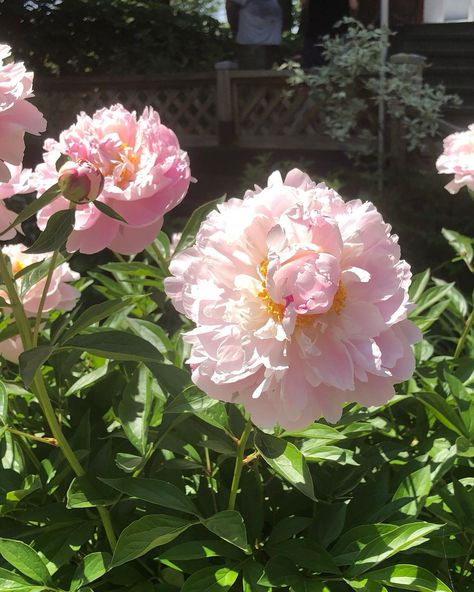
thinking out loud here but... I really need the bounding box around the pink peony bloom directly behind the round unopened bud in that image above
[34,104,191,255]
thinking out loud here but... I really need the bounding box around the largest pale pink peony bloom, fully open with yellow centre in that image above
[166,169,420,429]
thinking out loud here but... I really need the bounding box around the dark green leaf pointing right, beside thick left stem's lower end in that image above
[100,477,199,516]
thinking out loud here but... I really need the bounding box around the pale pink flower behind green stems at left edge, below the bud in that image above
[0,244,81,362]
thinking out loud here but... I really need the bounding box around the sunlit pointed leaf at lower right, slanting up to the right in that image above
[346,522,442,577]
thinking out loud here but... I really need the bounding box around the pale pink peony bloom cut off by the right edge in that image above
[436,123,474,193]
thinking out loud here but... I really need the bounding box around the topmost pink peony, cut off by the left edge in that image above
[0,45,46,183]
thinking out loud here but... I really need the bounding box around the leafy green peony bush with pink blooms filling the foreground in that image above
[0,40,474,592]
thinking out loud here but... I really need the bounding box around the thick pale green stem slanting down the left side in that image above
[0,252,117,550]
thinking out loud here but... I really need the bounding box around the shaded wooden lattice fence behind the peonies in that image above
[35,70,340,150]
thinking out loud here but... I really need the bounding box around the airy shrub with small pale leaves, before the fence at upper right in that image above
[290,19,459,158]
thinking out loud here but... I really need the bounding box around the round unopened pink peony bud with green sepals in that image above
[58,160,104,204]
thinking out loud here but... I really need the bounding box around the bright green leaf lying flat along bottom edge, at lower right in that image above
[365,564,452,592]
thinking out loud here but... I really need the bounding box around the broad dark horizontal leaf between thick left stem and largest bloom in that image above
[60,329,162,363]
